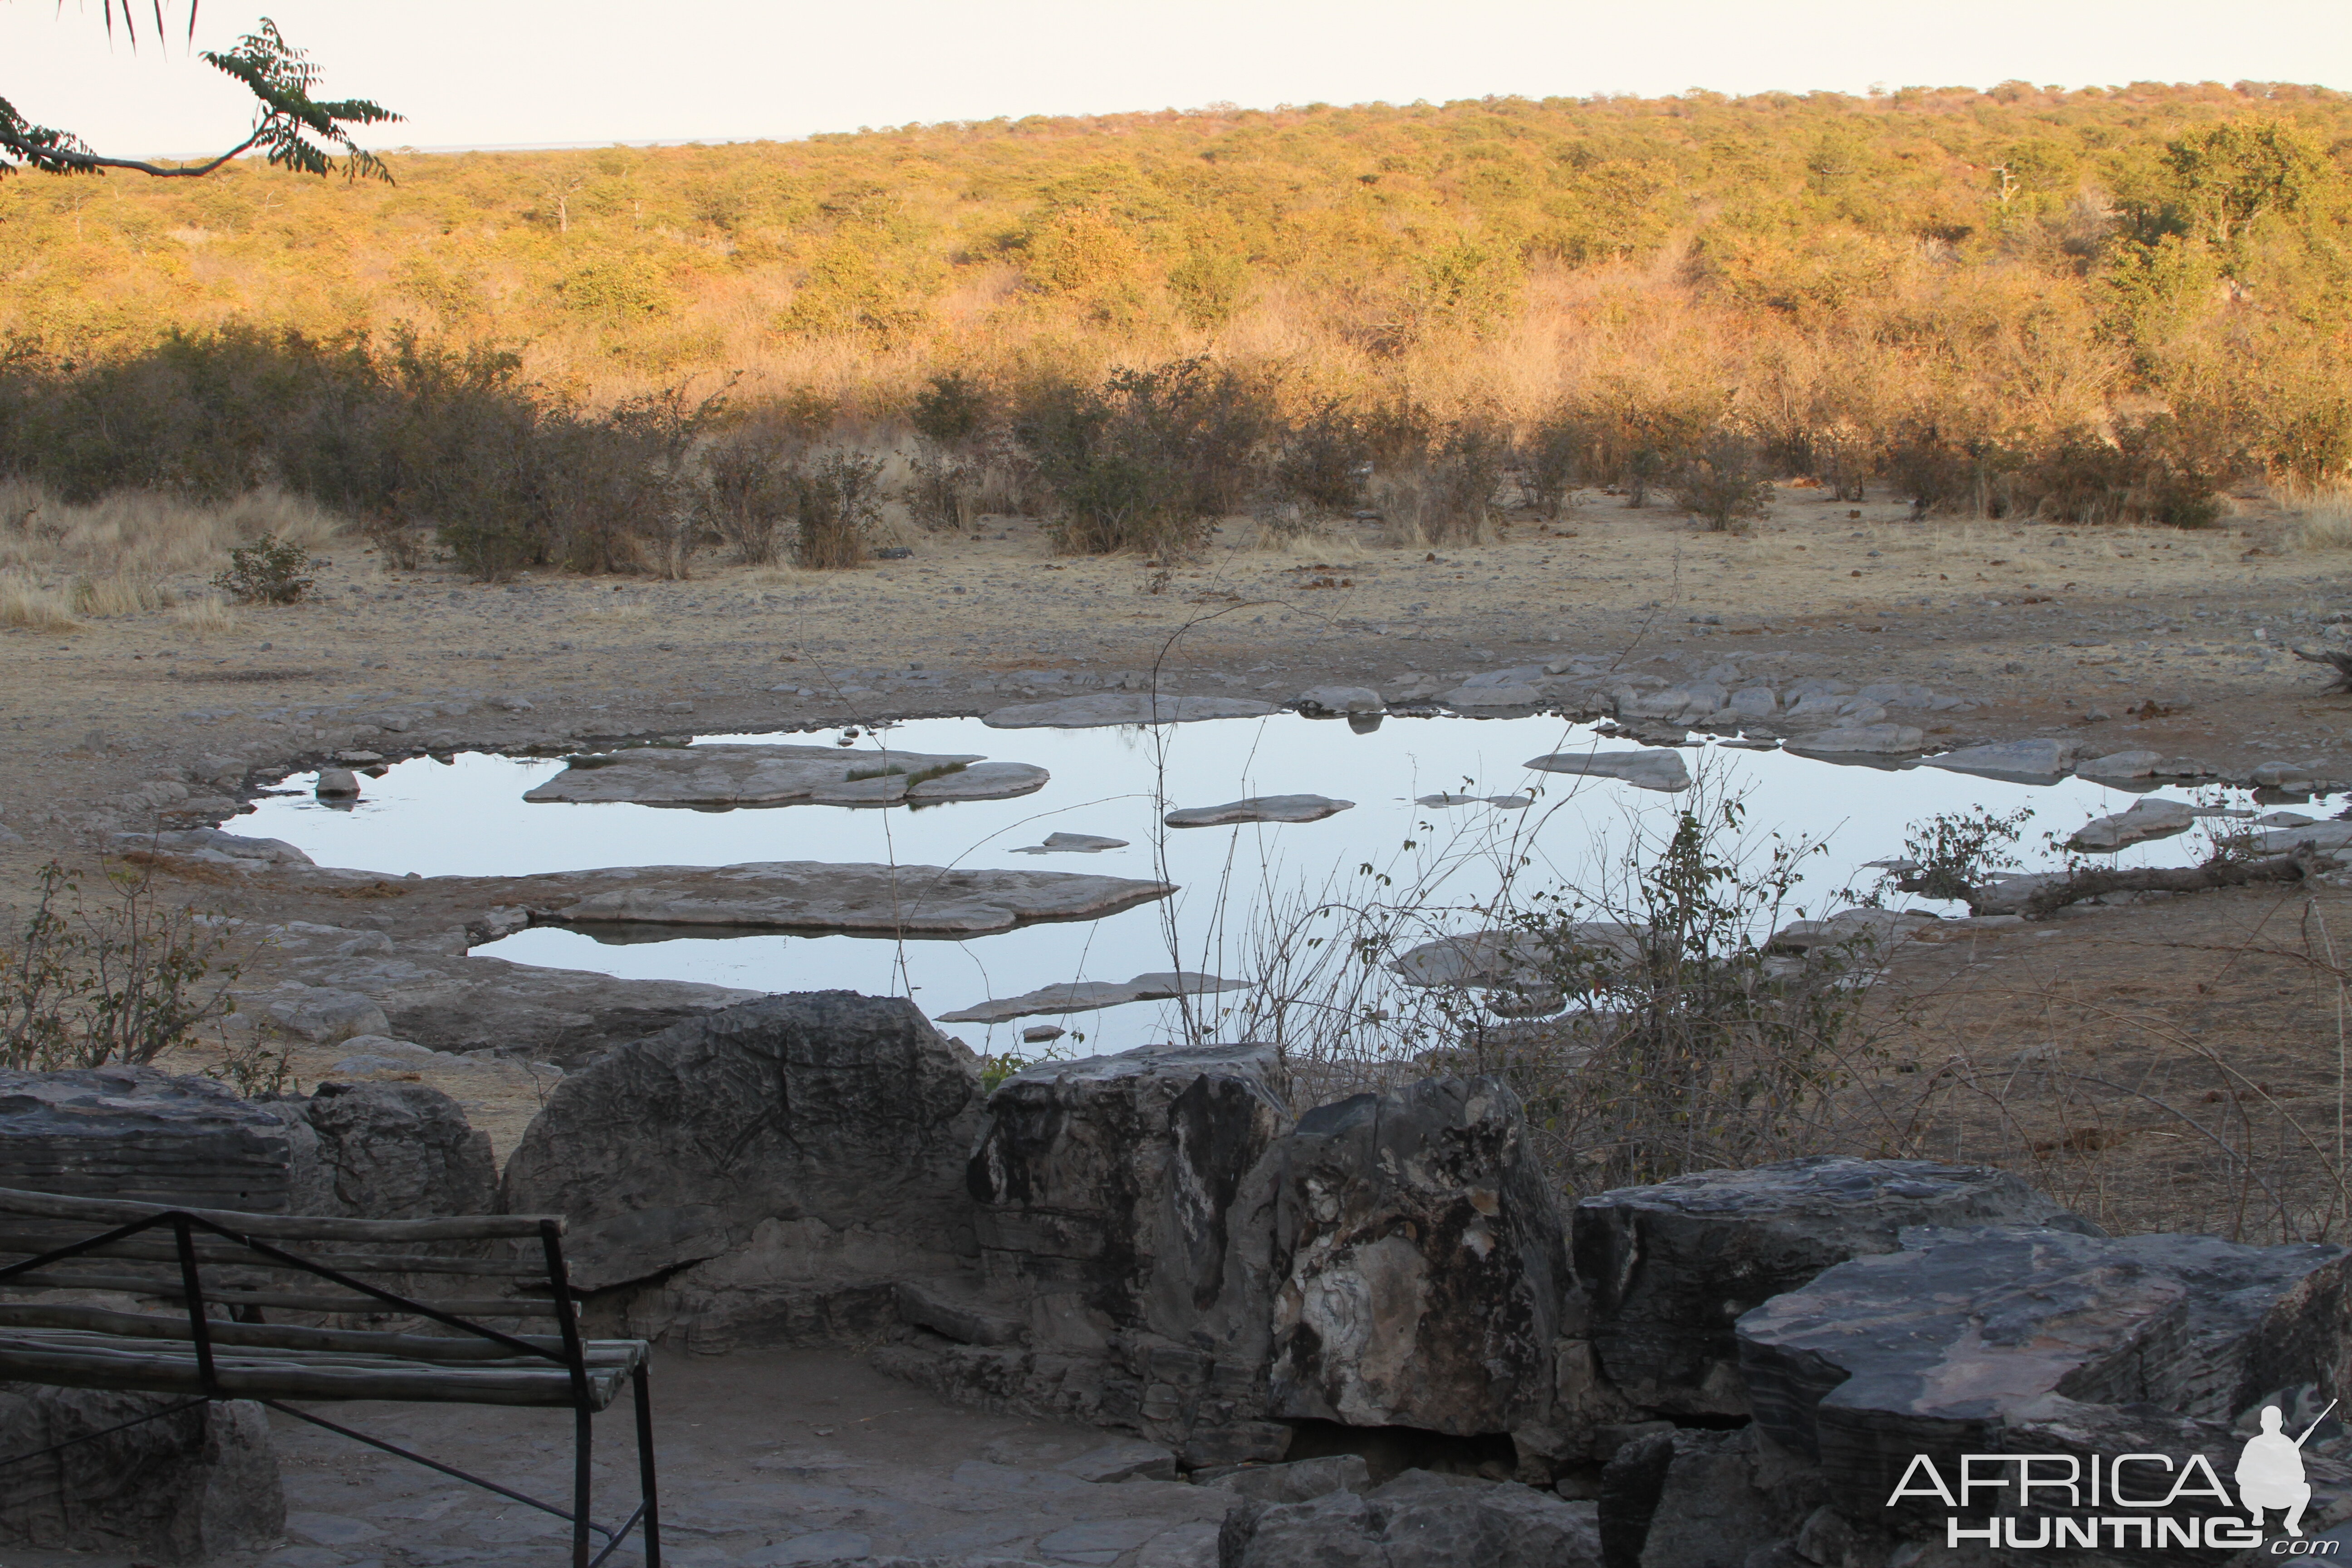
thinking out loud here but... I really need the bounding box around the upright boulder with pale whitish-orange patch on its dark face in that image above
[1270,1077,1567,1434]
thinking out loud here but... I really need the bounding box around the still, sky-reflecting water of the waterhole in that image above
[230,712,2314,1051]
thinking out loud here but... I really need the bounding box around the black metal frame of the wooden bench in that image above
[0,1208,661,1568]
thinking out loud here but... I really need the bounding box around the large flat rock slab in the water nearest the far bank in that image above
[539,745,1049,808]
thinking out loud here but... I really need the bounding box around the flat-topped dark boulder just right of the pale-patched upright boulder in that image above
[1573,1154,2096,1415]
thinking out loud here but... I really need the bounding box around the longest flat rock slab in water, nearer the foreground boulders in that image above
[534,860,1176,936]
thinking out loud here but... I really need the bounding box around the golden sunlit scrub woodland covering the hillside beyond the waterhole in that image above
[0,82,2352,569]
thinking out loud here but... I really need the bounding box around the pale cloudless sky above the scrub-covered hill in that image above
[0,0,2352,157]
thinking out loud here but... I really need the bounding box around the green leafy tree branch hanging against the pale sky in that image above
[0,0,400,181]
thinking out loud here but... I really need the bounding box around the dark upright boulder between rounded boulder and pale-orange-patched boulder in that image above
[967,1046,1289,1457]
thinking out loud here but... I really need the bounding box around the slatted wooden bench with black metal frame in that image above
[0,1187,661,1568]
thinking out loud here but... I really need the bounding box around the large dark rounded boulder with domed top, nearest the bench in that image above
[503,992,981,1349]
